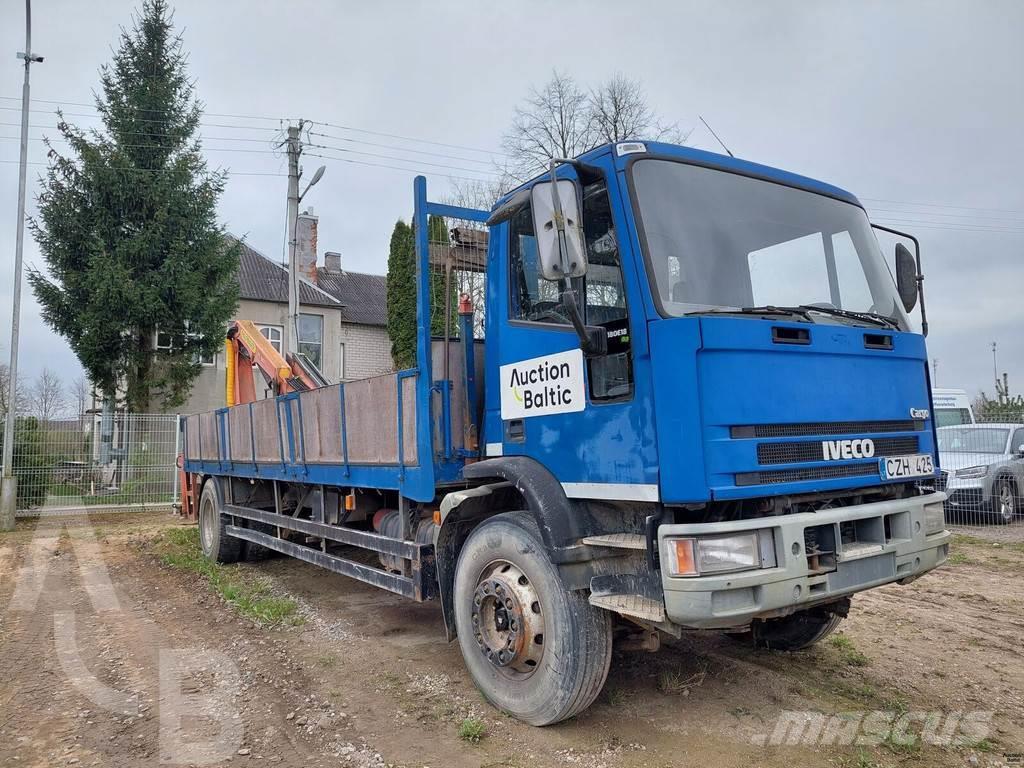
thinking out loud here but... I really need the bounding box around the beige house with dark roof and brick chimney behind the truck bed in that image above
[179,211,394,414]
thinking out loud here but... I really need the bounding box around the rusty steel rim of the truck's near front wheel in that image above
[471,560,544,677]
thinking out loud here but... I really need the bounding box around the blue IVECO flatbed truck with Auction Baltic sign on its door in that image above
[183,142,949,725]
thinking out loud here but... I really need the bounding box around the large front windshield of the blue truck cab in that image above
[633,159,908,329]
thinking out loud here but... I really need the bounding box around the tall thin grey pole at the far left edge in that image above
[0,0,43,530]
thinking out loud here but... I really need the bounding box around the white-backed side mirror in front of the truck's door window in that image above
[530,179,587,281]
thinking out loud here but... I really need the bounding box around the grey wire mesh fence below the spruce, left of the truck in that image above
[0,414,179,516]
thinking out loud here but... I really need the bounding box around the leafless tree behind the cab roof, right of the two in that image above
[587,74,689,143]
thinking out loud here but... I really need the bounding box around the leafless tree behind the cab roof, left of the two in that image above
[502,70,595,182]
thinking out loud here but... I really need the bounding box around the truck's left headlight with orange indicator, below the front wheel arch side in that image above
[664,530,775,577]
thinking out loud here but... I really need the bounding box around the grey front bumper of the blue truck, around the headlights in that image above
[657,493,951,629]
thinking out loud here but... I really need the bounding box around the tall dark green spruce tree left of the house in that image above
[29,0,239,411]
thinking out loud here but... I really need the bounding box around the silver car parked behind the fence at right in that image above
[936,424,1024,523]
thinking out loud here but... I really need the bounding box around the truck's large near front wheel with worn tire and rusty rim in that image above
[454,512,611,725]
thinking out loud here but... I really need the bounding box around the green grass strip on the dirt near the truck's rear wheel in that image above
[152,527,305,627]
